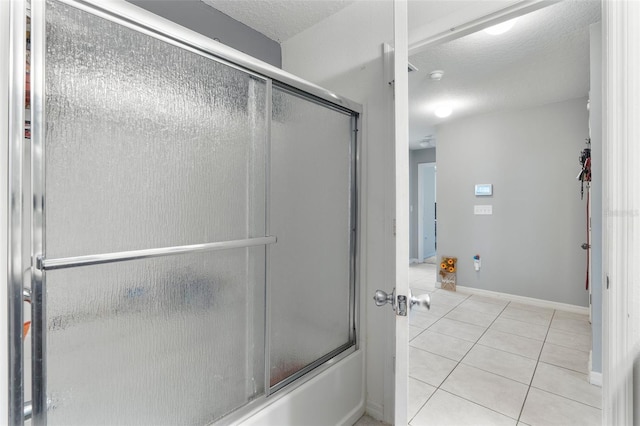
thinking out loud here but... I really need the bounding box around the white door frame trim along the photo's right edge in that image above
[602,0,640,425]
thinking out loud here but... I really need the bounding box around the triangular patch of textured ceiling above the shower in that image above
[202,0,354,43]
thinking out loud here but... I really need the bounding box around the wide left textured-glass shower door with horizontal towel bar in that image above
[35,1,270,425]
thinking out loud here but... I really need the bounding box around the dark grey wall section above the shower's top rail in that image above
[127,0,282,68]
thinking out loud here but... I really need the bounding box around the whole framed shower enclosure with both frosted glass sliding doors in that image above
[6,0,361,425]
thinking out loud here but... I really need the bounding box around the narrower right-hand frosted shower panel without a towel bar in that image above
[270,88,351,385]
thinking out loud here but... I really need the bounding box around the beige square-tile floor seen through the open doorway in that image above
[356,264,602,426]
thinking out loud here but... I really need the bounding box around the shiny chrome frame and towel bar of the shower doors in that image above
[8,0,362,424]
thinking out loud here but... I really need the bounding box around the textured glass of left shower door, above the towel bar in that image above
[45,1,267,258]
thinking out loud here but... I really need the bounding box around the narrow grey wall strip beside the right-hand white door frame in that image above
[589,22,603,373]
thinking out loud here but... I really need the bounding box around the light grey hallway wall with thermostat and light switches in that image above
[437,98,588,306]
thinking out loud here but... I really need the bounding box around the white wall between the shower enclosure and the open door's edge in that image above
[282,1,395,422]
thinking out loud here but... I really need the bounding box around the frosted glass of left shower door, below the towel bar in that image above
[46,247,265,425]
